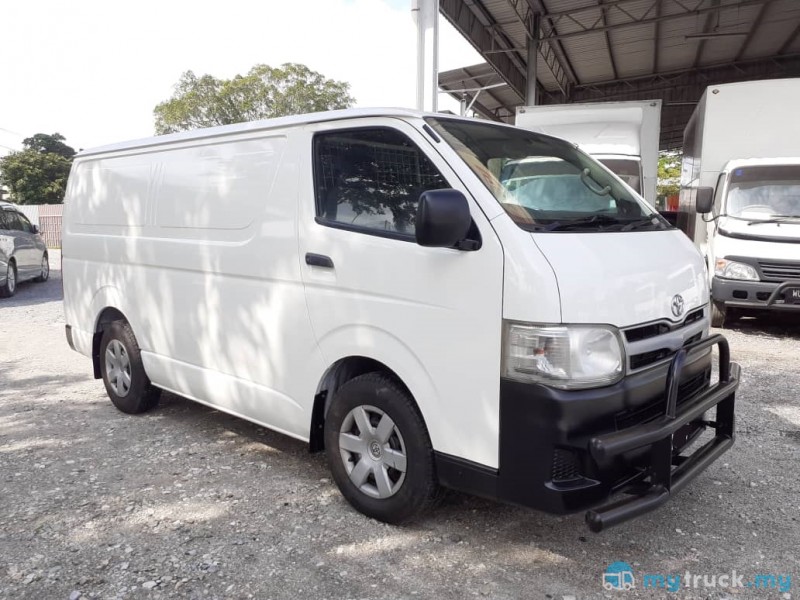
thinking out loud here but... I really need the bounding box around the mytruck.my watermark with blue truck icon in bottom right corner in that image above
[603,561,792,593]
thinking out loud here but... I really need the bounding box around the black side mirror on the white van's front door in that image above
[416,190,472,248]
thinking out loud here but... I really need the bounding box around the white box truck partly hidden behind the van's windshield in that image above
[514,100,661,206]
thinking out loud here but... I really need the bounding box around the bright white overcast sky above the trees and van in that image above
[0,0,479,148]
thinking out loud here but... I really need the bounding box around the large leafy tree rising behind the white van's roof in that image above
[153,63,354,134]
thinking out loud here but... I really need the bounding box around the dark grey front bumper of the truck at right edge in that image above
[711,276,800,312]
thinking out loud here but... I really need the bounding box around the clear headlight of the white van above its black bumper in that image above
[503,322,624,389]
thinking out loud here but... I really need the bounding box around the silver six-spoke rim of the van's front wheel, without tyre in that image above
[339,405,408,500]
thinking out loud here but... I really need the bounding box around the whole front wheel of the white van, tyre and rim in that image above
[325,373,439,524]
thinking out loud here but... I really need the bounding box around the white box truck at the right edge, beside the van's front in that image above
[678,79,800,327]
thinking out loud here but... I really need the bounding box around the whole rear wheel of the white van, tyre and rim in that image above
[100,321,161,415]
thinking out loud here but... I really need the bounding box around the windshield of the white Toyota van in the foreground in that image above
[426,117,670,232]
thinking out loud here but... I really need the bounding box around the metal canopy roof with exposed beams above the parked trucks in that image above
[439,0,800,148]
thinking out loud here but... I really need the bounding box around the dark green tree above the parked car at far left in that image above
[0,133,75,204]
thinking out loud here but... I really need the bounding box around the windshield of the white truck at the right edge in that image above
[727,165,800,221]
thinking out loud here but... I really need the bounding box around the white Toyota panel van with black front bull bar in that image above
[63,109,738,531]
